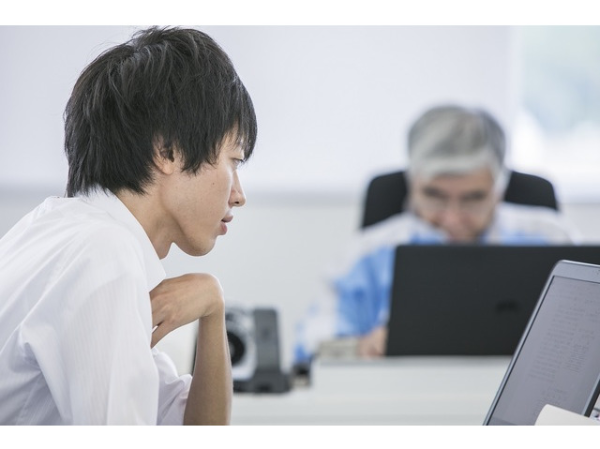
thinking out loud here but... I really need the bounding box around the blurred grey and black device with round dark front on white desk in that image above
[225,307,290,393]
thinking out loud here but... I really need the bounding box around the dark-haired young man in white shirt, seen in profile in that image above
[0,28,257,424]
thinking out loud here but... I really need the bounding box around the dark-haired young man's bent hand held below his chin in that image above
[150,273,225,346]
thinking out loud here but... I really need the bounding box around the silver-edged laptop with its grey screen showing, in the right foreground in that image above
[484,261,600,425]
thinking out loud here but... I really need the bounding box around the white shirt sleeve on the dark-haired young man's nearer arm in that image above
[26,228,159,425]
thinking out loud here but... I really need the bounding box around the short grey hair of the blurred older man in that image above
[408,105,507,190]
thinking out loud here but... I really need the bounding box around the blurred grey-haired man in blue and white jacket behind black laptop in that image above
[295,105,577,365]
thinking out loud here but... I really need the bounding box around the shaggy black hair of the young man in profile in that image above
[64,27,257,196]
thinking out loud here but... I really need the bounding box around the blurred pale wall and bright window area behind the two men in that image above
[0,25,600,372]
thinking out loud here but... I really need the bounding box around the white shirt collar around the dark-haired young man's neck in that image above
[80,189,166,291]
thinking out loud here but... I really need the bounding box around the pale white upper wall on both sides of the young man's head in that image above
[0,26,514,195]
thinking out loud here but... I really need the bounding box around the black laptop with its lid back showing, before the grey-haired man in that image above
[386,245,600,356]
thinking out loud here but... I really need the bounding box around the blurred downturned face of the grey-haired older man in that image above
[410,168,498,243]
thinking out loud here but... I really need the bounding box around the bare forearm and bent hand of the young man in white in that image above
[150,274,233,425]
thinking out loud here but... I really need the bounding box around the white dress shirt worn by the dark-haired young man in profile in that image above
[0,192,191,425]
